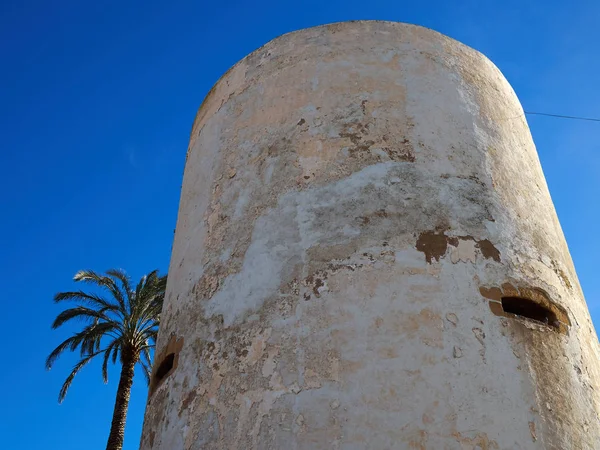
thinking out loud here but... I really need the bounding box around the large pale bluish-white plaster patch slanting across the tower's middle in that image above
[206,162,402,326]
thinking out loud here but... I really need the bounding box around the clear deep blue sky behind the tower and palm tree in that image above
[0,0,600,450]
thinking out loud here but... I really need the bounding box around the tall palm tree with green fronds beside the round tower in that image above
[46,269,167,450]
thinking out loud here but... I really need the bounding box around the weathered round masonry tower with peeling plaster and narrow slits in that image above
[141,22,600,450]
